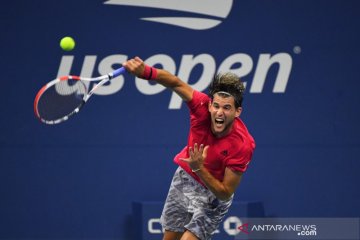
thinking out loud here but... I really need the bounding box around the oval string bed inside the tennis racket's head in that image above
[37,79,87,121]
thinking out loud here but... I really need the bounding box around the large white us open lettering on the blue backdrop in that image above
[58,53,292,109]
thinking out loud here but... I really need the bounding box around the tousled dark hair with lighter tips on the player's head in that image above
[208,72,245,108]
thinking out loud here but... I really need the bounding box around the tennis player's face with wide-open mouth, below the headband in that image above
[209,94,242,137]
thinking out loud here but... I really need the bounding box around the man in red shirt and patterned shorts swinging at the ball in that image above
[123,57,255,240]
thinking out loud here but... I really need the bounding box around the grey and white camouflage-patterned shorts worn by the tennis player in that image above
[161,167,232,240]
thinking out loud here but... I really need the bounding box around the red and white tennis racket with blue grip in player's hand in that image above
[34,67,126,124]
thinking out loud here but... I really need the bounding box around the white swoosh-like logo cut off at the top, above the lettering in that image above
[104,0,233,30]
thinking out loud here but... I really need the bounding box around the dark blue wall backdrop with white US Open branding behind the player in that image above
[0,0,360,240]
